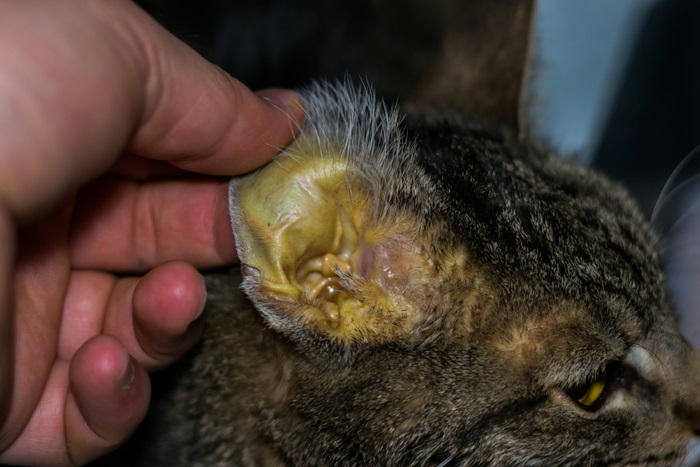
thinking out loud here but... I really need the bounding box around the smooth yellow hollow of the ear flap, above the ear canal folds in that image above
[237,145,356,297]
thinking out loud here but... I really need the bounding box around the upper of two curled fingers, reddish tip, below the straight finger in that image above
[104,262,206,370]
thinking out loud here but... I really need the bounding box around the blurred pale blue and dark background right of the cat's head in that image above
[530,0,700,347]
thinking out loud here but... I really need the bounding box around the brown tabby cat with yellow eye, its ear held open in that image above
[104,1,700,467]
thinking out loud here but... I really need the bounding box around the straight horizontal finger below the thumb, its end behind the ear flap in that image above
[69,177,236,272]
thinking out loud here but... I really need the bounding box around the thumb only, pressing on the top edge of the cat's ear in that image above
[117,0,303,175]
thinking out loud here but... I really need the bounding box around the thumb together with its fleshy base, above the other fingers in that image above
[0,0,303,221]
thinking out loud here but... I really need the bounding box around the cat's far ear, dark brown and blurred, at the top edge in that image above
[408,0,536,133]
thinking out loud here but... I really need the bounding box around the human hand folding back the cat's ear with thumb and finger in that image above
[0,0,303,465]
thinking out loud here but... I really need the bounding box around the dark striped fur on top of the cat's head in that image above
[410,113,670,322]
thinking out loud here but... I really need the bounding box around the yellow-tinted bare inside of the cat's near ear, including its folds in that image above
[236,142,425,342]
